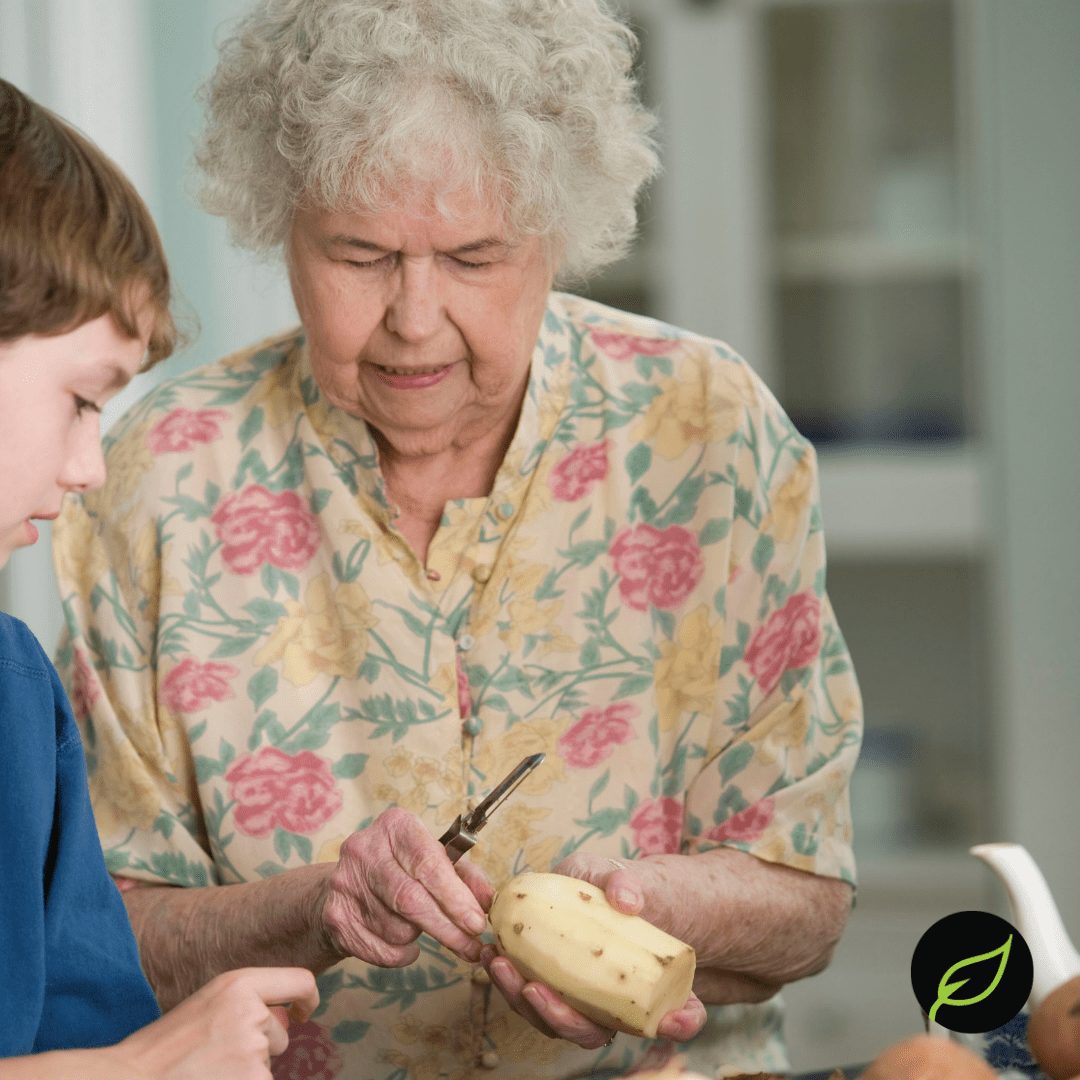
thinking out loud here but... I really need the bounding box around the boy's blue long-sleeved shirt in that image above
[0,612,160,1058]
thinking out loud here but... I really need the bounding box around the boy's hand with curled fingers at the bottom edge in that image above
[114,968,319,1080]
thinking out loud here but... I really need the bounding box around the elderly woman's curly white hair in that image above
[197,0,659,282]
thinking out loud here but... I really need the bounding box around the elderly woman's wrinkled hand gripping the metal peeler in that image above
[322,809,492,968]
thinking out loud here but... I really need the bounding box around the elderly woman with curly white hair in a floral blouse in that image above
[57,0,860,1078]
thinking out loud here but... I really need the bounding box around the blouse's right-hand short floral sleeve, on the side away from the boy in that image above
[686,362,862,883]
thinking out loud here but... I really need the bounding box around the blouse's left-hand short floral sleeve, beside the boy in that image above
[53,455,217,886]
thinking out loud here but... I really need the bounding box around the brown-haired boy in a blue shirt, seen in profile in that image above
[0,80,318,1080]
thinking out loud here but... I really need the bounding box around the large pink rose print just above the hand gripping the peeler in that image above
[225,746,341,836]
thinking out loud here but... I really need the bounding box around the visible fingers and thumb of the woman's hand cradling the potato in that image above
[482,853,705,1050]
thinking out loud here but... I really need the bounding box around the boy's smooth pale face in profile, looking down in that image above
[0,315,146,566]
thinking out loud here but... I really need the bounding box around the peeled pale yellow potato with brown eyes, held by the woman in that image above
[488,874,697,1038]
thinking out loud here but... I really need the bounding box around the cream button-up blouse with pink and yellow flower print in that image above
[55,293,861,1080]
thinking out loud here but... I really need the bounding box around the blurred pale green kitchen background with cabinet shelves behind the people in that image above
[0,0,1080,1068]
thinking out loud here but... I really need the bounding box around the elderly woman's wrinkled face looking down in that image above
[288,195,552,457]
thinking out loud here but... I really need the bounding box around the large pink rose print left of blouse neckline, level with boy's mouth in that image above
[211,484,319,573]
